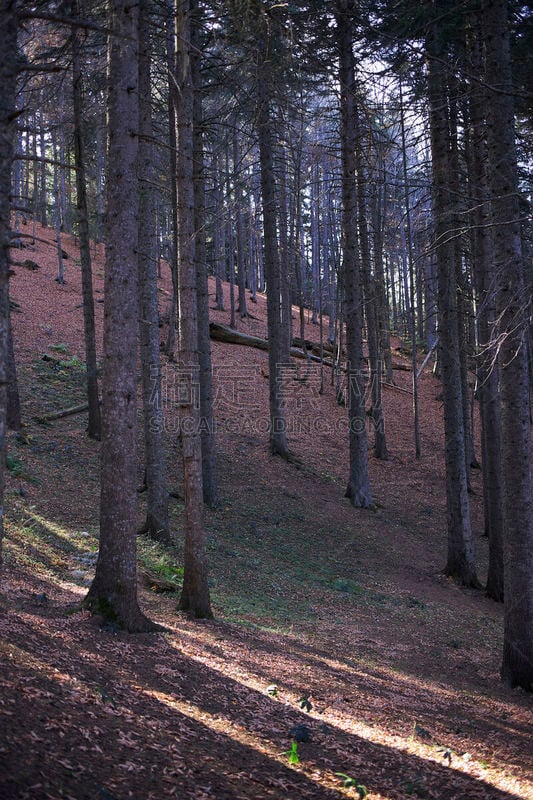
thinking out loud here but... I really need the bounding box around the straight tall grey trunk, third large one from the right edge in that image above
[427,9,478,586]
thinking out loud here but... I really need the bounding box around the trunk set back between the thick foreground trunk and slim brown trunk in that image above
[137,0,172,544]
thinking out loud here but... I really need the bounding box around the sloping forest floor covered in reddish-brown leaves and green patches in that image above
[0,224,533,800]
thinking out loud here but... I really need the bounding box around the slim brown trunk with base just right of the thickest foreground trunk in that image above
[173,0,213,618]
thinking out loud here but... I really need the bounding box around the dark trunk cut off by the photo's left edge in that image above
[0,0,18,563]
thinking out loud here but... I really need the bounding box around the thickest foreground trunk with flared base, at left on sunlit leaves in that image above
[85,0,154,632]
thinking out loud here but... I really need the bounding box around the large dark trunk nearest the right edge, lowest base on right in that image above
[482,0,533,691]
